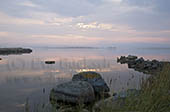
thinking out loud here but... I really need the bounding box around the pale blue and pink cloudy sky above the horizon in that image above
[0,0,170,47]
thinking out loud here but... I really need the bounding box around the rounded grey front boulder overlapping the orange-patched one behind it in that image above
[50,81,95,104]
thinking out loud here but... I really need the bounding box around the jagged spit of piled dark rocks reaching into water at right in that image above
[117,55,170,75]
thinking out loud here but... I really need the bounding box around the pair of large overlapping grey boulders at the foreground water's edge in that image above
[50,72,110,112]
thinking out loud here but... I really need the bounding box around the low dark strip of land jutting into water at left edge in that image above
[0,48,32,55]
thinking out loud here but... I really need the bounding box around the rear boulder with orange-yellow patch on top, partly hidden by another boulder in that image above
[72,72,110,95]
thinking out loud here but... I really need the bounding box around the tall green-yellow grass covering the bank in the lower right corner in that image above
[100,65,170,112]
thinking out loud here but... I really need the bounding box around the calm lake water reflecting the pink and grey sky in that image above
[0,49,170,112]
